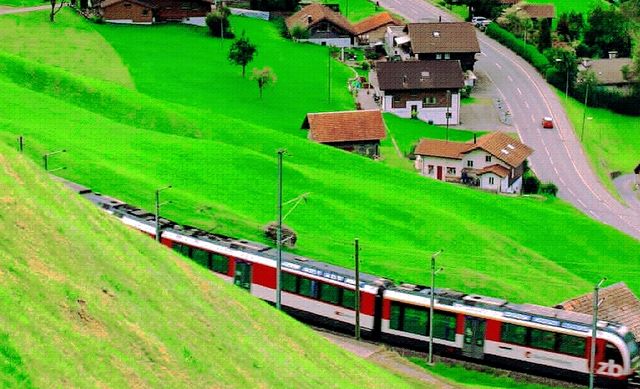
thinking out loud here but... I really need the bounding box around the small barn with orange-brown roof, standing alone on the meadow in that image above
[302,110,387,158]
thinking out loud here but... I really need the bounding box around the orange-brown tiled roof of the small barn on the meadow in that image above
[302,109,387,143]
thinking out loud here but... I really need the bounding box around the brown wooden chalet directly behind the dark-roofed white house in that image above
[405,22,480,71]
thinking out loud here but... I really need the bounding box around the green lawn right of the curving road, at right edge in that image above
[556,91,640,193]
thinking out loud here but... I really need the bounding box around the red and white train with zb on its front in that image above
[65,181,640,386]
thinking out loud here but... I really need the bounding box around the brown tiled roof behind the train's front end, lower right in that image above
[560,282,640,341]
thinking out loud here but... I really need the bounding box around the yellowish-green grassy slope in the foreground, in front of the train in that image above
[0,144,416,388]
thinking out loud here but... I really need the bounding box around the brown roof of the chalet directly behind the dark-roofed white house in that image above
[407,22,480,54]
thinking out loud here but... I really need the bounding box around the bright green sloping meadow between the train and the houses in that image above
[0,9,640,310]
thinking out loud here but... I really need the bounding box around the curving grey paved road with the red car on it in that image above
[380,0,640,239]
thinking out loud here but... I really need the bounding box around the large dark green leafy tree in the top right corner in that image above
[584,7,631,58]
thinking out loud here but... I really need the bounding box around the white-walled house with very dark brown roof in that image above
[376,60,464,125]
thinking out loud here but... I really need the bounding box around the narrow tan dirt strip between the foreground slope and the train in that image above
[316,329,457,389]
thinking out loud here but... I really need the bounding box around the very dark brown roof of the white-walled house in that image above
[376,60,464,91]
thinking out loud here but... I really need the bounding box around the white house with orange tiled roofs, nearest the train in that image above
[414,132,533,193]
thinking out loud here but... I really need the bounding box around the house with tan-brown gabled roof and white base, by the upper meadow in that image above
[285,3,357,47]
